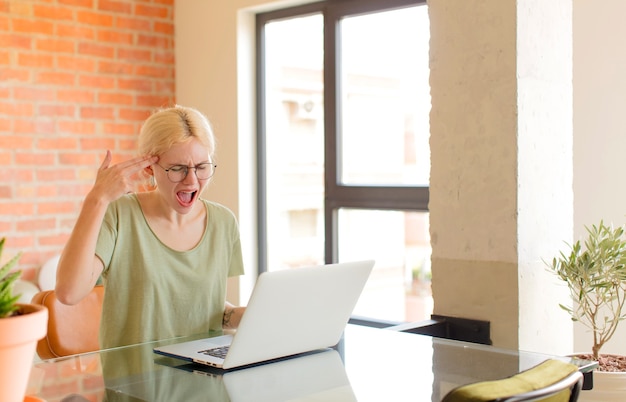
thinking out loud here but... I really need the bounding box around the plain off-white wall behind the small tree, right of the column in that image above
[573,0,626,354]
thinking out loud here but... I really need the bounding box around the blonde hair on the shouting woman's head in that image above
[138,105,215,160]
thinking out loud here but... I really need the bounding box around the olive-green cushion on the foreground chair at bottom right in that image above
[442,360,578,402]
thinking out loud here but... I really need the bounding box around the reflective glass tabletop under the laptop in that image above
[27,325,597,402]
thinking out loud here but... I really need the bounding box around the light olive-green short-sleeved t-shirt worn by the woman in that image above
[96,194,243,348]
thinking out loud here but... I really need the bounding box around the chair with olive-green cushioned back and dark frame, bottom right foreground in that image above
[442,359,583,402]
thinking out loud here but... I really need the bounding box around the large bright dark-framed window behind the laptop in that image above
[257,0,432,322]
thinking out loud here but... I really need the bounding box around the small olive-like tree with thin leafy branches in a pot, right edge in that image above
[548,221,626,402]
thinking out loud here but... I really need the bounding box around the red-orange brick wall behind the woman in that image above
[0,0,174,281]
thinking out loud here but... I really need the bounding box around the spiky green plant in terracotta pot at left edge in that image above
[0,238,48,402]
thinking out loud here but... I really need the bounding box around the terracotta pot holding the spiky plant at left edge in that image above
[0,304,48,402]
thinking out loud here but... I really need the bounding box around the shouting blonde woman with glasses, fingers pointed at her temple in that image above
[56,106,244,348]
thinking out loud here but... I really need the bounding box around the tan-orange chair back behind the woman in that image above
[32,285,104,359]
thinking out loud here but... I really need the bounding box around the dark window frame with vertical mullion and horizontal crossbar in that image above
[256,0,429,273]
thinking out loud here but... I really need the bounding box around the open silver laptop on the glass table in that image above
[153,260,374,370]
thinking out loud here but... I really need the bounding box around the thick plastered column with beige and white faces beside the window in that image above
[429,0,573,353]
